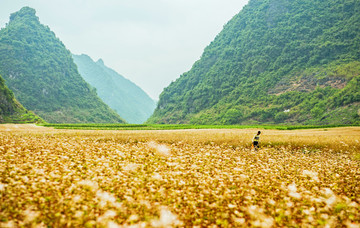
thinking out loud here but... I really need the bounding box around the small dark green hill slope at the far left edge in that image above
[0,76,44,123]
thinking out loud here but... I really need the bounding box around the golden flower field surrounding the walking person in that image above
[0,125,360,227]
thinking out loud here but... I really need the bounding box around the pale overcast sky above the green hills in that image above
[0,0,248,99]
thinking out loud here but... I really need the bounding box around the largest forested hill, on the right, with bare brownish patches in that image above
[149,0,360,124]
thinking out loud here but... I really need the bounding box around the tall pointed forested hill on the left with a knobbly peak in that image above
[0,7,124,123]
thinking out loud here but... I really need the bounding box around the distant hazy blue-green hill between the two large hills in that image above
[73,54,155,124]
